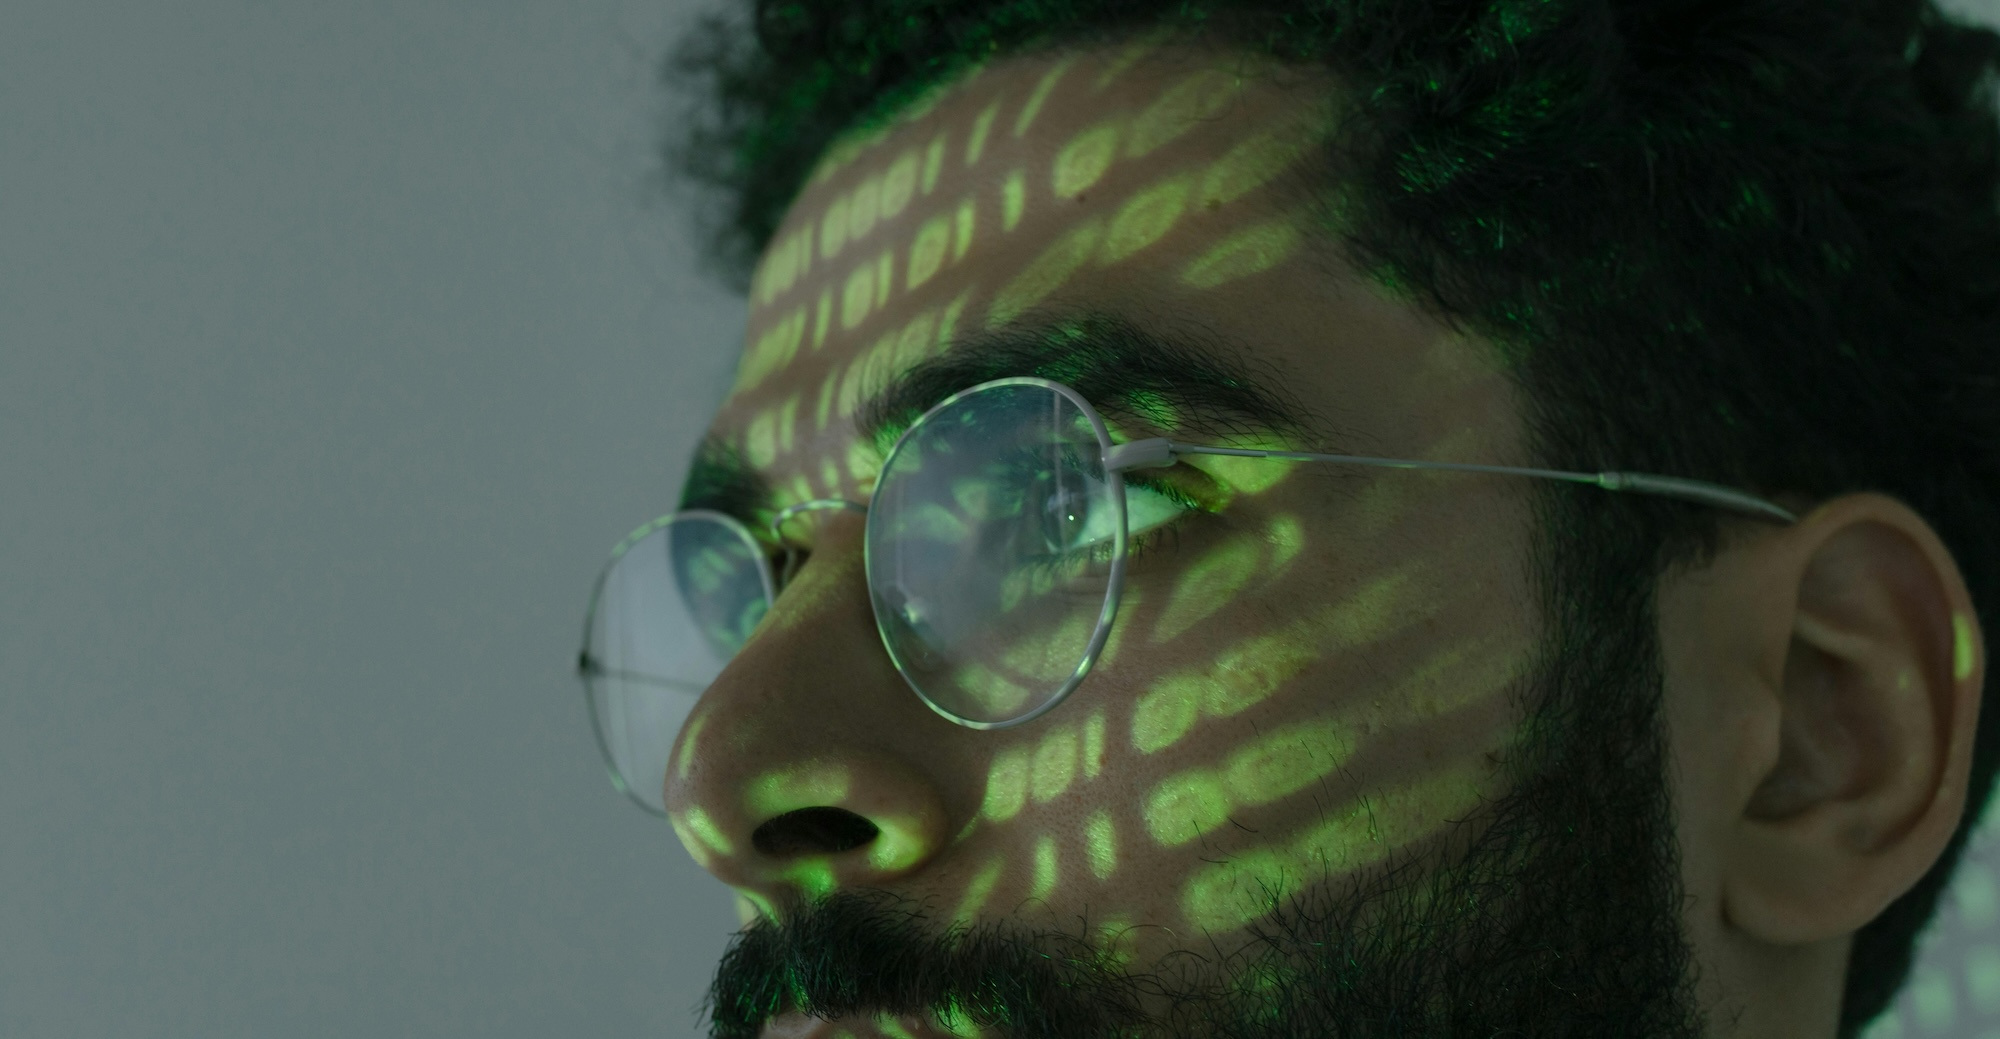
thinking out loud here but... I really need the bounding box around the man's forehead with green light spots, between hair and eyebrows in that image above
[714,38,1504,507]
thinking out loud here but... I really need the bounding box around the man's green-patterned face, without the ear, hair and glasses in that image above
[664,46,1704,1035]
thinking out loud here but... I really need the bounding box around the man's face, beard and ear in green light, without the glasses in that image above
[664,46,1984,1037]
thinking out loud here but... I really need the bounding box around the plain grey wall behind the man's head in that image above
[11,0,2000,1039]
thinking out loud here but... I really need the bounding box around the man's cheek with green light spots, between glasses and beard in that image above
[944,507,1530,931]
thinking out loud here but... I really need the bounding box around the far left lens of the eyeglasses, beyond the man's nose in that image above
[582,512,772,815]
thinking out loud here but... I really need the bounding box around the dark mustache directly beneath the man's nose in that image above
[704,889,1158,1039]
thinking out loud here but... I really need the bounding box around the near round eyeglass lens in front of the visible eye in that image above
[868,380,1124,727]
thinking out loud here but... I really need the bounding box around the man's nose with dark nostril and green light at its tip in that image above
[664,516,956,909]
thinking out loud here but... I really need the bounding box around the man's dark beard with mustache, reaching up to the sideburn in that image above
[706,535,1704,1039]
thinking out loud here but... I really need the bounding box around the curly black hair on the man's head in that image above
[662,0,2000,1037]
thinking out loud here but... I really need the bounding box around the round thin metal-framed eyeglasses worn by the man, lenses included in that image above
[578,376,1794,815]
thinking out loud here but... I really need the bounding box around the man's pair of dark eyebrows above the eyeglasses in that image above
[680,310,1330,529]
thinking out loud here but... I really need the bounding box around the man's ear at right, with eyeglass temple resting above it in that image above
[1716,494,1986,945]
